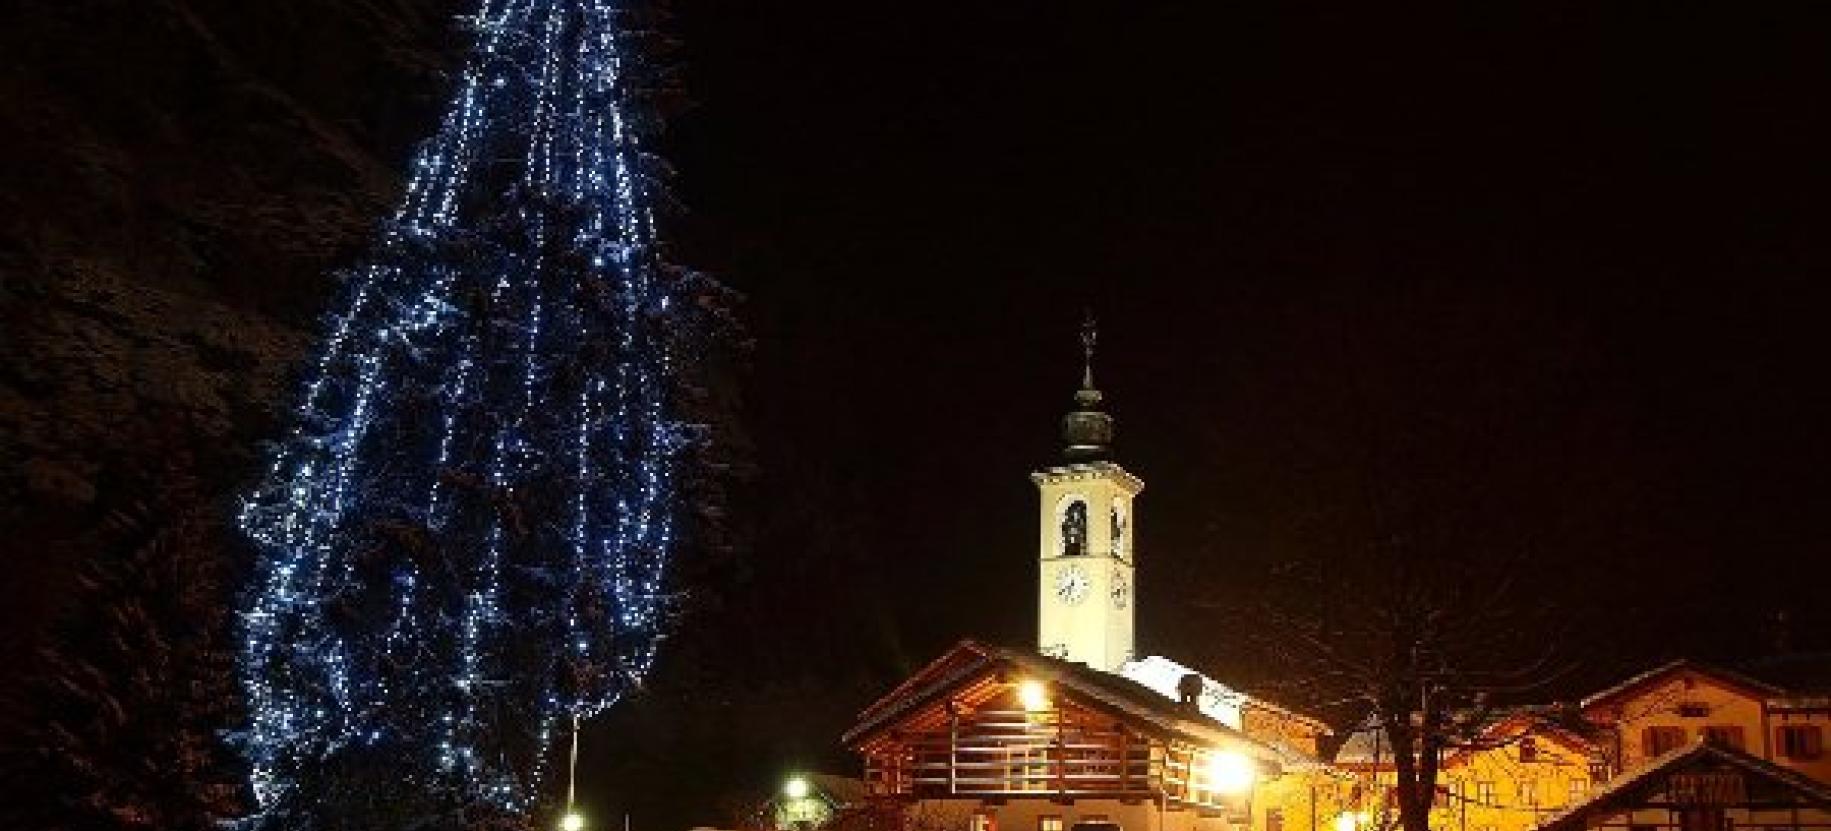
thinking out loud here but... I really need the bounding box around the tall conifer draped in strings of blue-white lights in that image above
[240,0,716,827]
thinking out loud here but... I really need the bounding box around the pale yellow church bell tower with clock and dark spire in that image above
[1031,318,1144,672]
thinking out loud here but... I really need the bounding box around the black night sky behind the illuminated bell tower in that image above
[3,0,1831,827]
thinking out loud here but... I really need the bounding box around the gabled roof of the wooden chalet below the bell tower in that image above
[842,641,1316,767]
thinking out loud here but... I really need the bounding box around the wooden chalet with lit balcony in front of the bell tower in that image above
[844,641,1315,831]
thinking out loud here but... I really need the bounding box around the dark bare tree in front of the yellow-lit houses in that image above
[1214,281,1647,831]
